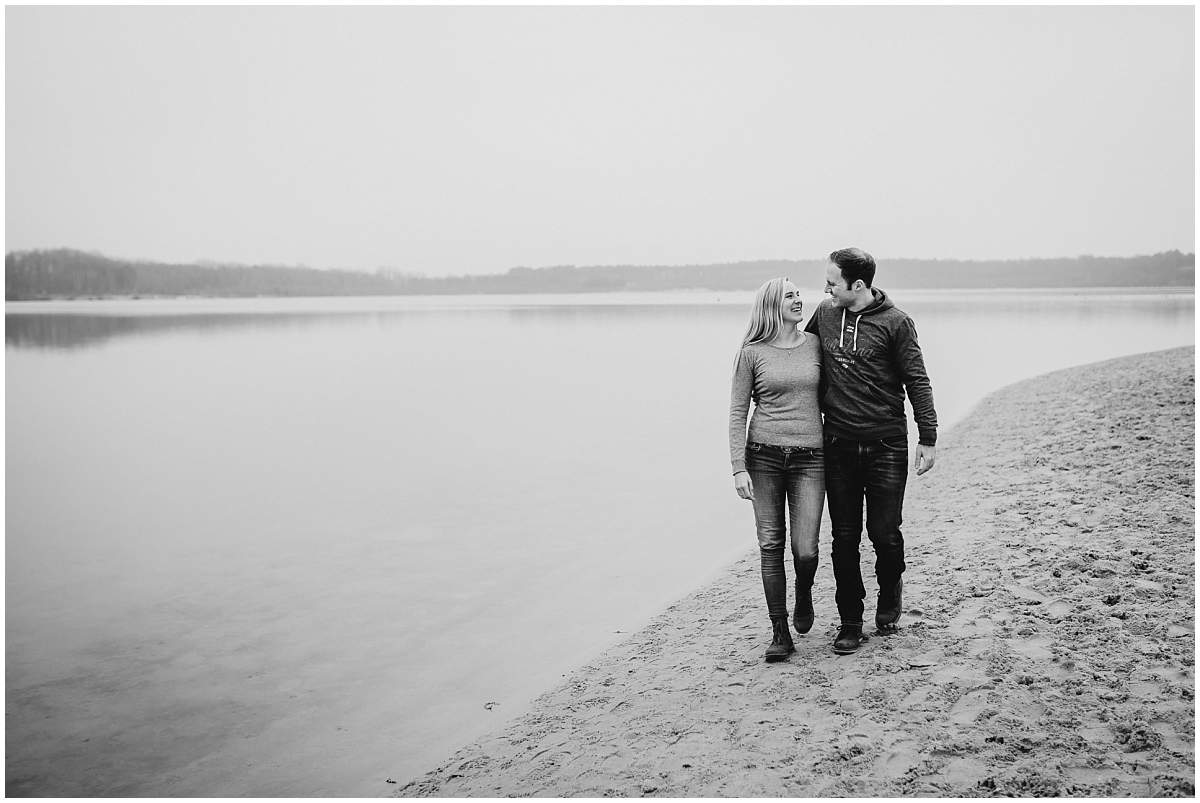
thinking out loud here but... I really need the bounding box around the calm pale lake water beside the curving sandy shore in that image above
[5,289,1194,796]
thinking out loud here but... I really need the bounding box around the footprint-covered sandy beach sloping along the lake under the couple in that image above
[396,347,1195,797]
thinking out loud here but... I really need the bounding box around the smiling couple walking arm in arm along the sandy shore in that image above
[730,248,937,661]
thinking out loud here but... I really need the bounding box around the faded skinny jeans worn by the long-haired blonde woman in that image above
[746,443,826,621]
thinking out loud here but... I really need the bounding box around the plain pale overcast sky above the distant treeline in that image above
[5,6,1195,275]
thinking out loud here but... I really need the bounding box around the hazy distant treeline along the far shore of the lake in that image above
[5,248,1195,301]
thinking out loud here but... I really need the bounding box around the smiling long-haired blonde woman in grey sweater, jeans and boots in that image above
[730,277,824,661]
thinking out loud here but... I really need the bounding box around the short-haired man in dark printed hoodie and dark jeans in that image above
[805,248,937,655]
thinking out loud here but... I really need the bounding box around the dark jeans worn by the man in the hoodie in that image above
[824,435,908,624]
